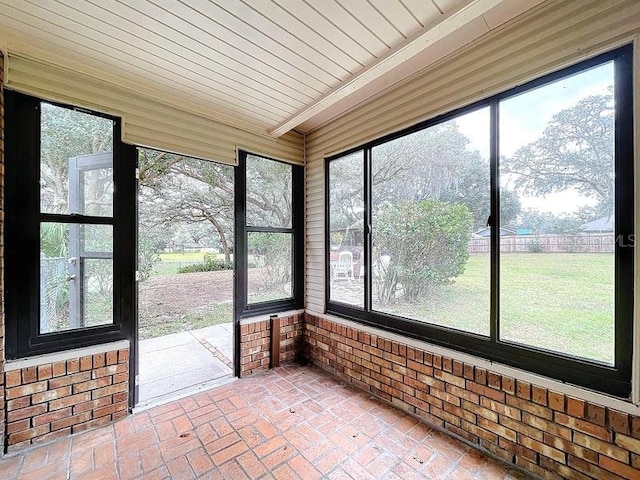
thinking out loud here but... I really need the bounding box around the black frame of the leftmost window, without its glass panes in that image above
[4,90,137,359]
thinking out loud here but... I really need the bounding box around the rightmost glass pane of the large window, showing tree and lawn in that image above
[500,62,615,364]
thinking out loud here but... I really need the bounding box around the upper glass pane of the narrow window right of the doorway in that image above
[246,155,292,228]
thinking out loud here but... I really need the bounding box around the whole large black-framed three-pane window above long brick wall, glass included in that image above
[326,47,634,397]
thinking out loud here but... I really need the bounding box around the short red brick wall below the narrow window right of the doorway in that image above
[240,314,304,377]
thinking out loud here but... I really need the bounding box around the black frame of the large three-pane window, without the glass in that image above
[325,45,635,399]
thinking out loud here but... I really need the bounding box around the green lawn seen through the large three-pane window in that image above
[380,253,614,363]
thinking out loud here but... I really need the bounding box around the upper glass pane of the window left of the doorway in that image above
[40,102,113,216]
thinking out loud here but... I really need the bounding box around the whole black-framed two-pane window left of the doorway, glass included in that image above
[5,92,135,358]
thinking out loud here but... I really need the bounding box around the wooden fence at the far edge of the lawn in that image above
[469,233,615,253]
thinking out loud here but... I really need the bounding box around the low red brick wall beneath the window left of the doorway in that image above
[4,349,129,450]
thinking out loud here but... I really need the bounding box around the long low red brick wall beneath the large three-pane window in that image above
[304,314,640,480]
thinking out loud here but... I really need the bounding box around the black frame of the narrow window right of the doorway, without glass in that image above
[234,150,304,319]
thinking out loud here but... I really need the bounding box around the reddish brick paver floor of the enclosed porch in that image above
[0,366,526,480]
